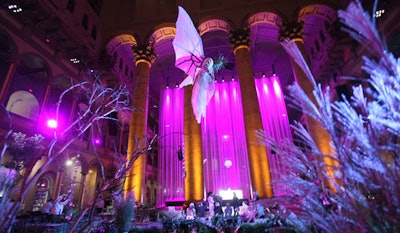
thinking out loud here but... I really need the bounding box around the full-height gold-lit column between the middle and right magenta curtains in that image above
[229,28,272,198]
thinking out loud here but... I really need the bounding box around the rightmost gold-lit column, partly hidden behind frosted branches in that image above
[280,22,338,189]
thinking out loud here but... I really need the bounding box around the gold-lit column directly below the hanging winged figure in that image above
[184,85,204,201]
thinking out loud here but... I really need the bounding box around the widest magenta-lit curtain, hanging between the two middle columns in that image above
[201,80,251,200]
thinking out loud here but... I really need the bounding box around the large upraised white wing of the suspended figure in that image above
[172,6,204,87]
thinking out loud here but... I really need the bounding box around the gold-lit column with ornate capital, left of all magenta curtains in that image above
[124,44,156,202]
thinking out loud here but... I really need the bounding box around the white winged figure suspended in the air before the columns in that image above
[172,6,223,123]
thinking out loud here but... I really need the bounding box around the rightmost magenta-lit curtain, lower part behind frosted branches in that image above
[255,75,292,196]
